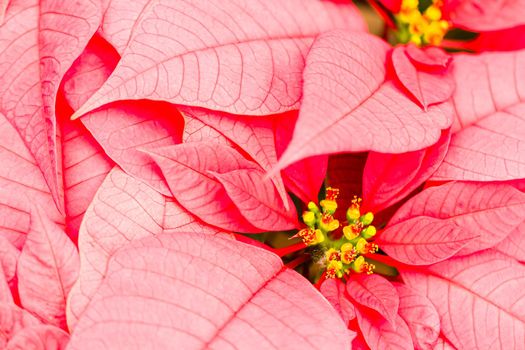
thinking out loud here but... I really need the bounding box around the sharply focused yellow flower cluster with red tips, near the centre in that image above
[297,187,378,278]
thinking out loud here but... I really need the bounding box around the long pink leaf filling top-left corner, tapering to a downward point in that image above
[0,0,101,211]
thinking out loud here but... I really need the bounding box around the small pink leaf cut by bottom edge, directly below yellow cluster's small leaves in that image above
[357,309,414,350]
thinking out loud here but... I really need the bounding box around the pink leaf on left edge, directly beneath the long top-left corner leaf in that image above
[0,114,64,249]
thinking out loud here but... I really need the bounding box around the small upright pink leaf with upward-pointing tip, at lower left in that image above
[18,208,79,329]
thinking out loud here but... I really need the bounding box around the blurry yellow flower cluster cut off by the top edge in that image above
[396,0,450,46]
